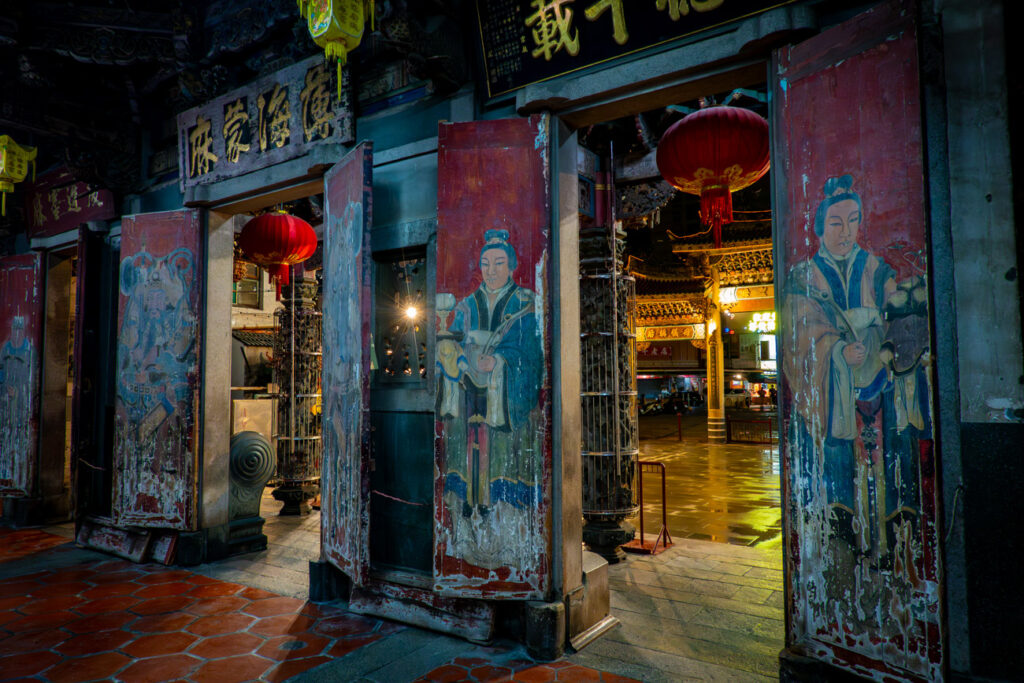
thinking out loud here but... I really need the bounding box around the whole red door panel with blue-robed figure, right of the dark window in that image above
[434,116,552,599]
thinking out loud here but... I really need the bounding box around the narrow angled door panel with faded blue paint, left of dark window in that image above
[321,142,373,586]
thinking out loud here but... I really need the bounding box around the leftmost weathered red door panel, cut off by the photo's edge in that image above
[0,254,43,496]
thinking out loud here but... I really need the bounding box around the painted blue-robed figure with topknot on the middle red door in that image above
[437,230,543,568]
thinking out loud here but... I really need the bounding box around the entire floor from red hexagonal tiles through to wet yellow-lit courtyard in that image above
[0,414,784,683]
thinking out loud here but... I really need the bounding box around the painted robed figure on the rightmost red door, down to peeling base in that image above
[783,175,934,671]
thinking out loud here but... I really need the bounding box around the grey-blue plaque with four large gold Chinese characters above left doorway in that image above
[178,56,353,190]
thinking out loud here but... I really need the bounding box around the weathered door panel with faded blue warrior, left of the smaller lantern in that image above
[114,210,203,529]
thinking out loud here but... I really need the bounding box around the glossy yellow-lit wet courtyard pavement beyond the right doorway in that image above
[630,413,782,546]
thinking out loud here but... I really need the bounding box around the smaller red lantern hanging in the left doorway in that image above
[239,211,316,299]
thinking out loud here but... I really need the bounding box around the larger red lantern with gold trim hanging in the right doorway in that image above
[657,106,769,249]
